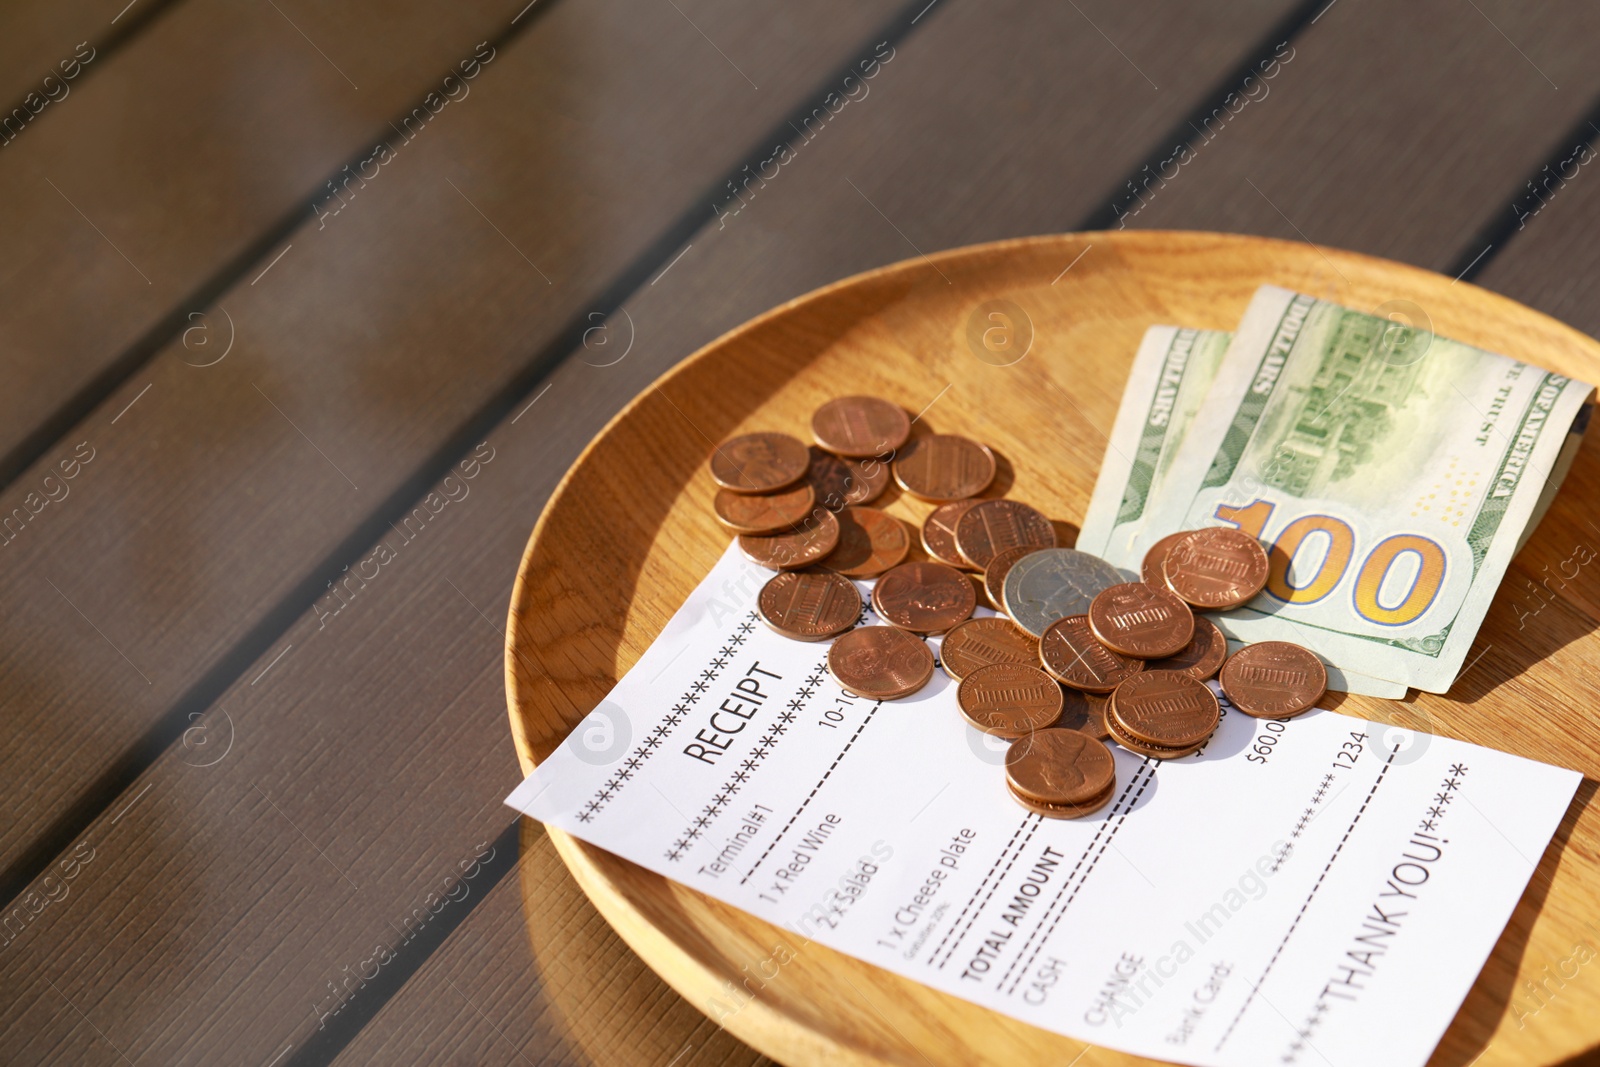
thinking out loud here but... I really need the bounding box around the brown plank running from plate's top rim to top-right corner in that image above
[1123,0,1600,271]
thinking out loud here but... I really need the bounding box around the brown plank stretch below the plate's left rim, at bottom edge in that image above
[336,821,771,1067]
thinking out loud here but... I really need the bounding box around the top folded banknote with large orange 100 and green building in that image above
[1139,286,1594,693]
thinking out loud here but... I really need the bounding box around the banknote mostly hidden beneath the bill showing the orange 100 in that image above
[1077,326,1406,699]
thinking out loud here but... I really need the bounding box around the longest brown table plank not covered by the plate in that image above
[0,0,890,883]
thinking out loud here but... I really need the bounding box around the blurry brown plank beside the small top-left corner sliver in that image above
[0,0,515,483]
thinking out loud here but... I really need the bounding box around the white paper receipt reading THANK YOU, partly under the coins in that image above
[507,547,1581,1067]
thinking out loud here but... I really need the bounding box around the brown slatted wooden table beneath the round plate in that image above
[0,0,1600,1067]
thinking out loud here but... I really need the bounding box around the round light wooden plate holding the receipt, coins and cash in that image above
[506,232,1600,1067]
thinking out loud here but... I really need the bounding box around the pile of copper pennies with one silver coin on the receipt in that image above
[710,397,1328,819]
